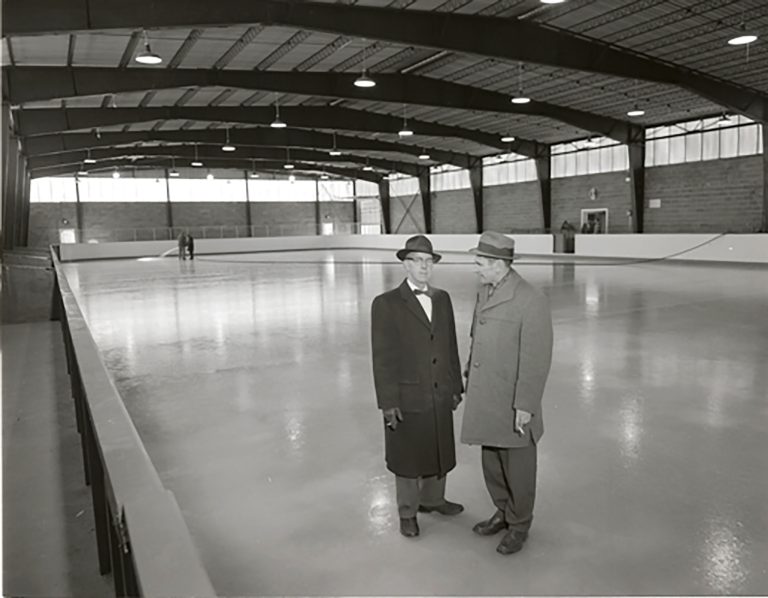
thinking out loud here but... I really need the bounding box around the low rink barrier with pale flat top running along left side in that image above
[51,247,216,598]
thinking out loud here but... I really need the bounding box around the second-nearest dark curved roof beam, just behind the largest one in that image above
[5,66,630,143]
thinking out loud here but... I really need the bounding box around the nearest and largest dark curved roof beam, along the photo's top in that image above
[3,0,768,122]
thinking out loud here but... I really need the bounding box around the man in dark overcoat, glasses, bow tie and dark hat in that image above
[371,235,464,537]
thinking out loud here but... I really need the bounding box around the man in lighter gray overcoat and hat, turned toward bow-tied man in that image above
[461,231,553,554]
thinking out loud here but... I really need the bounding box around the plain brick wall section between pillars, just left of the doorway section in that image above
[483,181,544,232]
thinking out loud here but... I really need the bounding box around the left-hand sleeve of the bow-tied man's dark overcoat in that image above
[371,296,400,409]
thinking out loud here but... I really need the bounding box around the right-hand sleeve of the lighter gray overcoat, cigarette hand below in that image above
[513,296,553,414]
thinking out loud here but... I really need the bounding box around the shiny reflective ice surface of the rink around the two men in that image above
[52,248,768,596]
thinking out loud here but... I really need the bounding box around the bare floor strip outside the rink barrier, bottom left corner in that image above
[0,322,113,598]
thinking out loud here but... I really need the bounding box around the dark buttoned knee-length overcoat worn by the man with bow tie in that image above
[371,281,462,478]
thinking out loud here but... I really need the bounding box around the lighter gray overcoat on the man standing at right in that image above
[461,270,552,448]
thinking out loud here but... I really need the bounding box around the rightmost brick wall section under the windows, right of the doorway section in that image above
[645,156,764,233]
